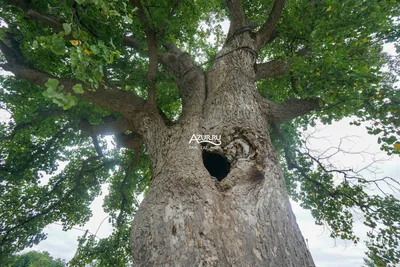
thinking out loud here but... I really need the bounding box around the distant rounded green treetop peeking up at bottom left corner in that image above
[9,251,65,267]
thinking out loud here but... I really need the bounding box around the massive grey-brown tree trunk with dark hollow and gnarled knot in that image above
[132,33,314,267]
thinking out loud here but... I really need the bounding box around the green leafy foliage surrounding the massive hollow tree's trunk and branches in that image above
[0,0,400,266]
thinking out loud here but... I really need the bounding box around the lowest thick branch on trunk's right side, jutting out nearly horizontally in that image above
[262,99,320,122]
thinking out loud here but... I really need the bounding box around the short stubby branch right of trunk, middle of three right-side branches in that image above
[255,60,290,81]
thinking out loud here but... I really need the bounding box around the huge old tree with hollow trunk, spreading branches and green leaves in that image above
[0,0,400,266]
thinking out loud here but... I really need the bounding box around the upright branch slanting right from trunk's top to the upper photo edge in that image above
[256,0,285,51]
